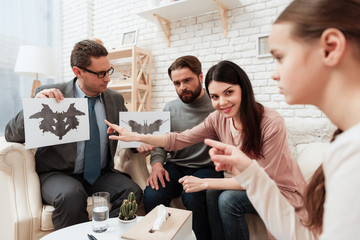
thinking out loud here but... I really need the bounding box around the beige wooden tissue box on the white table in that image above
[121,207,192,240]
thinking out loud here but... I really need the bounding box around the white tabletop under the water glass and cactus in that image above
[41,216,196,240]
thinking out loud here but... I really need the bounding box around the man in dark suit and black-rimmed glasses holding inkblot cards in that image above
[5,40,142,229]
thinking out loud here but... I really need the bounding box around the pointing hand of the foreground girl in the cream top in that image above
[205,139,253,176]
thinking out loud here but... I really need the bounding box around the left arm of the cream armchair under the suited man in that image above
[0,137,45,240]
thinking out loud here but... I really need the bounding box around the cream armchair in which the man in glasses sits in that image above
[0,137,148,240]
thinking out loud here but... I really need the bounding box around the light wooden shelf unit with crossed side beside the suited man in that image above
[108,46,152,112]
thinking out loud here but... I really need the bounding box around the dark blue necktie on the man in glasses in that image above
[84,96,101,184]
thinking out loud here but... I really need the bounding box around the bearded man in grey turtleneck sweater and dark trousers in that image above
[144,56,223,240]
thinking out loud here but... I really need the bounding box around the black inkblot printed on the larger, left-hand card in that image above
[29,103,85,140]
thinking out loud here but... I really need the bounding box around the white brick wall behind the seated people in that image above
[62,0,332,142]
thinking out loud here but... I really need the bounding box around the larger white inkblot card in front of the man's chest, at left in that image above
[23,98,89,149]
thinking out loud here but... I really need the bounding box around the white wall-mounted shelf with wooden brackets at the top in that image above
[137,0,240,46]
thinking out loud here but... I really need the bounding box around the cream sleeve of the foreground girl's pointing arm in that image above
[235,161,315,240]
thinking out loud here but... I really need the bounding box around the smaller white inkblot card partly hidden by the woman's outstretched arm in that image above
[119,112,170,148]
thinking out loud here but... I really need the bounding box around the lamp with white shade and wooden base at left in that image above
[14,45,56,97]
